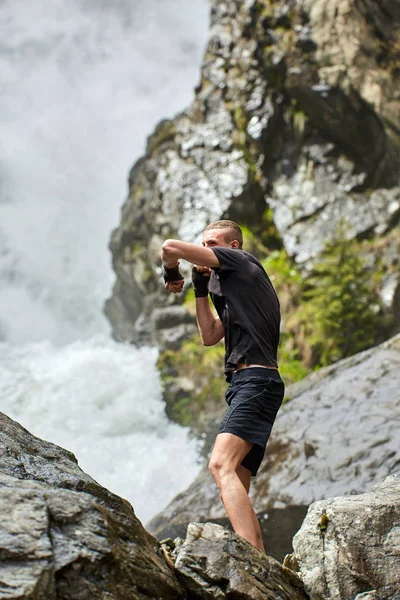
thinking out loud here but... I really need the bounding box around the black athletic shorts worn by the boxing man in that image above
[218,367,285,476]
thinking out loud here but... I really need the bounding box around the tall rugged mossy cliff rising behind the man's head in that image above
[105,0,400,347]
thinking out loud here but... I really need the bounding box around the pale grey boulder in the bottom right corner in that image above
[293,475,400,600]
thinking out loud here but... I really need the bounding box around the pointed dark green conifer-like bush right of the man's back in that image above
[292,226,379,366]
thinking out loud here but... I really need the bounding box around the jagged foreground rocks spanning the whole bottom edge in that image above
[0,413,400,600]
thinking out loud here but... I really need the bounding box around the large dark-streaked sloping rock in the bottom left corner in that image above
[0,413,184,600]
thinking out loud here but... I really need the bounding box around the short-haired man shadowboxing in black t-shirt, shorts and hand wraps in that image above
[161,221,284,550]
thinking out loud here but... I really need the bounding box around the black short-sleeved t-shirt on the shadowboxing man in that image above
[209,246,281,381]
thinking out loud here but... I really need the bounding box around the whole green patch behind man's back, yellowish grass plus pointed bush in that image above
[262,225,380,383]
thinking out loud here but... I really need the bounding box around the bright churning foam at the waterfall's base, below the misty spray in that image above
[0,336,202,520]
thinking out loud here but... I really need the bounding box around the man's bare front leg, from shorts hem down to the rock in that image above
[209,433,263,550]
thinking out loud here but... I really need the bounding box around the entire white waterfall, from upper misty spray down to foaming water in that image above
[0,0,209,520]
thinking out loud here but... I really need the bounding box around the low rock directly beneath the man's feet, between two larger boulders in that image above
[175,523,307,600]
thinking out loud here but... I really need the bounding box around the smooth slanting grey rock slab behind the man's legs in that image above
[148,336,400,555]
